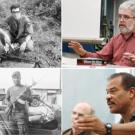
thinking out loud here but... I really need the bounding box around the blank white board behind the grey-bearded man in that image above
[62,0,101,39]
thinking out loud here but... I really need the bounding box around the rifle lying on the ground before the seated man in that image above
[0,53,42,68]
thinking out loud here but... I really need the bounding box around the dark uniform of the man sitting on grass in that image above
[0,15,33,51]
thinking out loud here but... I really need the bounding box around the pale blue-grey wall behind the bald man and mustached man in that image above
[62,69,115,130]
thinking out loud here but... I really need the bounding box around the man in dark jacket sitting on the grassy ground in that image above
[1,4,33,52]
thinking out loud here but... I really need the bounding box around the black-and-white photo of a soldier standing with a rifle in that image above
[0,68,62,135]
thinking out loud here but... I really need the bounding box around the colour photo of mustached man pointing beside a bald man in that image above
[62,68,135,135]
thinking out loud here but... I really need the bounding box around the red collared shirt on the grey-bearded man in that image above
[83,33,135,67]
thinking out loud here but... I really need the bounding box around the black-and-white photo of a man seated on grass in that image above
[0,0,61,68]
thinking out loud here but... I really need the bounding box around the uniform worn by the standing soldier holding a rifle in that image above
[6,85,32,135]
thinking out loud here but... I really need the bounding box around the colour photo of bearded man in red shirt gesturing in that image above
[62,0,135,68]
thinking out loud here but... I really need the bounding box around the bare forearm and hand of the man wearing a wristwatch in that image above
[74,116,135,135]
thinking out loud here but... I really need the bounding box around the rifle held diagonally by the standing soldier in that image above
[5,82,36,118]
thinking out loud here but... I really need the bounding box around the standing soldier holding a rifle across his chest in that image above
[6,71,32,135]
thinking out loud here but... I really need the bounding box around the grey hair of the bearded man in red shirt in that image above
[119,0,135,17]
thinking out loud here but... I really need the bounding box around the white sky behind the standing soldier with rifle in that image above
[0,68,60,89]
